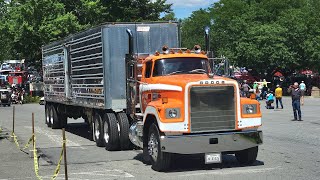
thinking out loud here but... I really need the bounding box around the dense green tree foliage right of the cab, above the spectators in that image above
[182,0,320,73]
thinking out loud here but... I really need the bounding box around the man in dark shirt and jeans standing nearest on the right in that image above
[288,82,303,121]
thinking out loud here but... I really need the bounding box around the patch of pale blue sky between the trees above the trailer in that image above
[167,0,219,19]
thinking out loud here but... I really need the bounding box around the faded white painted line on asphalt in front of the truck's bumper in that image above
[179,166,281,177]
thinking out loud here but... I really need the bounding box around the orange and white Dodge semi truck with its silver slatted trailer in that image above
[43,23,262,171]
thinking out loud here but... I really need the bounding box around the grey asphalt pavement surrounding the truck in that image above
[0,98,320,180]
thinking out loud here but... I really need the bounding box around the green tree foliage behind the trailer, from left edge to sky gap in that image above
[0,0,172,64]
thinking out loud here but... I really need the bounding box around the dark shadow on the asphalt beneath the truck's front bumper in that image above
[134,153,264,173]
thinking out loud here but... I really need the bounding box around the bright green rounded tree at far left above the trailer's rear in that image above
[2,0,82,62]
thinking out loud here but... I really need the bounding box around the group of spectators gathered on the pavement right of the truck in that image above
[240,80,306,121]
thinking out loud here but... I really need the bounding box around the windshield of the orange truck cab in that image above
[153,58,209,77]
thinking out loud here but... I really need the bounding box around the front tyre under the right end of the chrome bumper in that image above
[235,146,258,165]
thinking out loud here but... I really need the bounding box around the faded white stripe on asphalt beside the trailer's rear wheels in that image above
[24,126,86,149]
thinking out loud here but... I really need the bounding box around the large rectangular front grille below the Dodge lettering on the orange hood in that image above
[190,86,236,132]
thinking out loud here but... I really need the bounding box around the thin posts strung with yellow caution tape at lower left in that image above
[9,106,68,180]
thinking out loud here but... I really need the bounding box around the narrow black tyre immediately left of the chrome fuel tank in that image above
[117,113,133,150]
